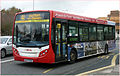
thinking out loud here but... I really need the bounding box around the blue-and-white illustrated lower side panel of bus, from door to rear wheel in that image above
[68,41,107,61]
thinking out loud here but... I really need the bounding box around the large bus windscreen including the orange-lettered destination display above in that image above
[13,12,50,47]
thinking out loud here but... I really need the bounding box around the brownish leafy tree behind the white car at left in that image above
[1,7,22,35]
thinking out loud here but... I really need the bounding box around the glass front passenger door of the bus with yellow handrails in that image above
[55,22,67,61]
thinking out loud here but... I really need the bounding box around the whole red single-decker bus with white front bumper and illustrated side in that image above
[12,10,115,63]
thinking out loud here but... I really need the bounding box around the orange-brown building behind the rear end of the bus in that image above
[98,10,120,34]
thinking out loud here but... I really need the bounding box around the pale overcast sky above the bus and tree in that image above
[0,0,120,18]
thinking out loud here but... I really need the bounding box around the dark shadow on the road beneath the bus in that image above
[17,52,111,69]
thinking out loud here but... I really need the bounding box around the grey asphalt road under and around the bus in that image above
[1,42,119,75]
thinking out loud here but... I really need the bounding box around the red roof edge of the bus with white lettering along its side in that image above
[16,10,115,25]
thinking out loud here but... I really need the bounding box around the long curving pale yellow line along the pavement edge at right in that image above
[76,53,120,76]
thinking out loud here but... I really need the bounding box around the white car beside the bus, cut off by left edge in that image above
[0,36,13,58]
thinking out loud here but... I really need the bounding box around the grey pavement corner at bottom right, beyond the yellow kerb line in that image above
[88,65,120,76]
